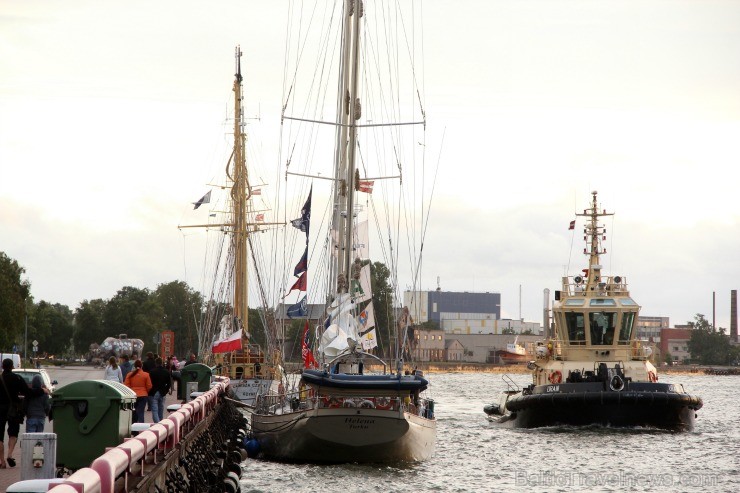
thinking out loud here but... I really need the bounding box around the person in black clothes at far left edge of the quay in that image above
[0,358,49,469]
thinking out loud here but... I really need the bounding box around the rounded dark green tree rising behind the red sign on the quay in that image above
[154,281,202,355]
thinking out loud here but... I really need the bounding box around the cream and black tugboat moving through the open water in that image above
[484,192,703,431]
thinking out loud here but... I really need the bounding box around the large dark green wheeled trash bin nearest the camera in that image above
[51,380,136,470]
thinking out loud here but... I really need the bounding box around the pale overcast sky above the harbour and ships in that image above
[0,0,740,328]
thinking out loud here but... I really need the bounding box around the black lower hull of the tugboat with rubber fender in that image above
[485,391,702,431]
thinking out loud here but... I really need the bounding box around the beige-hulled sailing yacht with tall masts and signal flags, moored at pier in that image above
[250,0,436,464]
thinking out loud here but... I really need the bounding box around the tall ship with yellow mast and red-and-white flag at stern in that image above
[180,46,281,405]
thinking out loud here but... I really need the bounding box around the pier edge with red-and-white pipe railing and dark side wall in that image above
[0,367,245,493]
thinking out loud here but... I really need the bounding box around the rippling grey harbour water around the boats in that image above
[241,373,740,493]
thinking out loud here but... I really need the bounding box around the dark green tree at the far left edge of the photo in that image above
[0,252,31,352]
